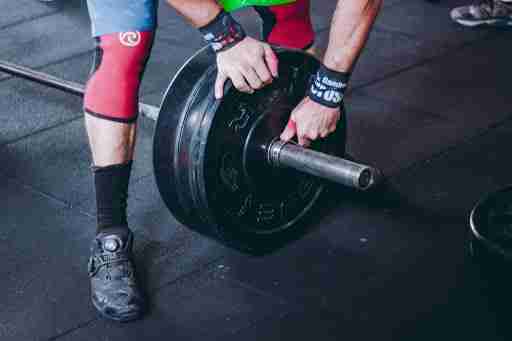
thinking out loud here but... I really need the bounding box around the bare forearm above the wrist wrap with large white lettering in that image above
[323,0,382,72]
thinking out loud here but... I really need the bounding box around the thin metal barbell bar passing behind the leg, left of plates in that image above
[0,60,160,121]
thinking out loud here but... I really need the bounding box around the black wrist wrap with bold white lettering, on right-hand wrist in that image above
[308,65,350,108]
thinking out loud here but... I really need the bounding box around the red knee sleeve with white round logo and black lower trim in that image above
[84,32,153,123]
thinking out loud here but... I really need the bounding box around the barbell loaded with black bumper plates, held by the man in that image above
[0,47,381,251]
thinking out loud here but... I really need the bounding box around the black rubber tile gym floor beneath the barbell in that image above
[0,0,512,341]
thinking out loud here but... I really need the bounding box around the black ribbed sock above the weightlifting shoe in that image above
[92,161,132,233]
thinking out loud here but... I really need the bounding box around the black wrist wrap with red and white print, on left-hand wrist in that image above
[199,11,246,52]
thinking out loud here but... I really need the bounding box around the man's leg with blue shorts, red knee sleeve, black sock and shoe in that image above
[84,0,156,321]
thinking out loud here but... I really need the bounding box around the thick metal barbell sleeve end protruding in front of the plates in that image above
[268,140,380,190]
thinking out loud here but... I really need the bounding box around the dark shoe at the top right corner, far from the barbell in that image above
[450,0,512,27]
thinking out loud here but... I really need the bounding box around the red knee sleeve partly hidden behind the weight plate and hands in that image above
[259,0,315,49]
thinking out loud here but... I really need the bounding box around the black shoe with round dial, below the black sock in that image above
[89,228,144,322]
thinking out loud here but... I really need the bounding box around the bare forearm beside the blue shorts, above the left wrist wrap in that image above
[167,0,222,28]
